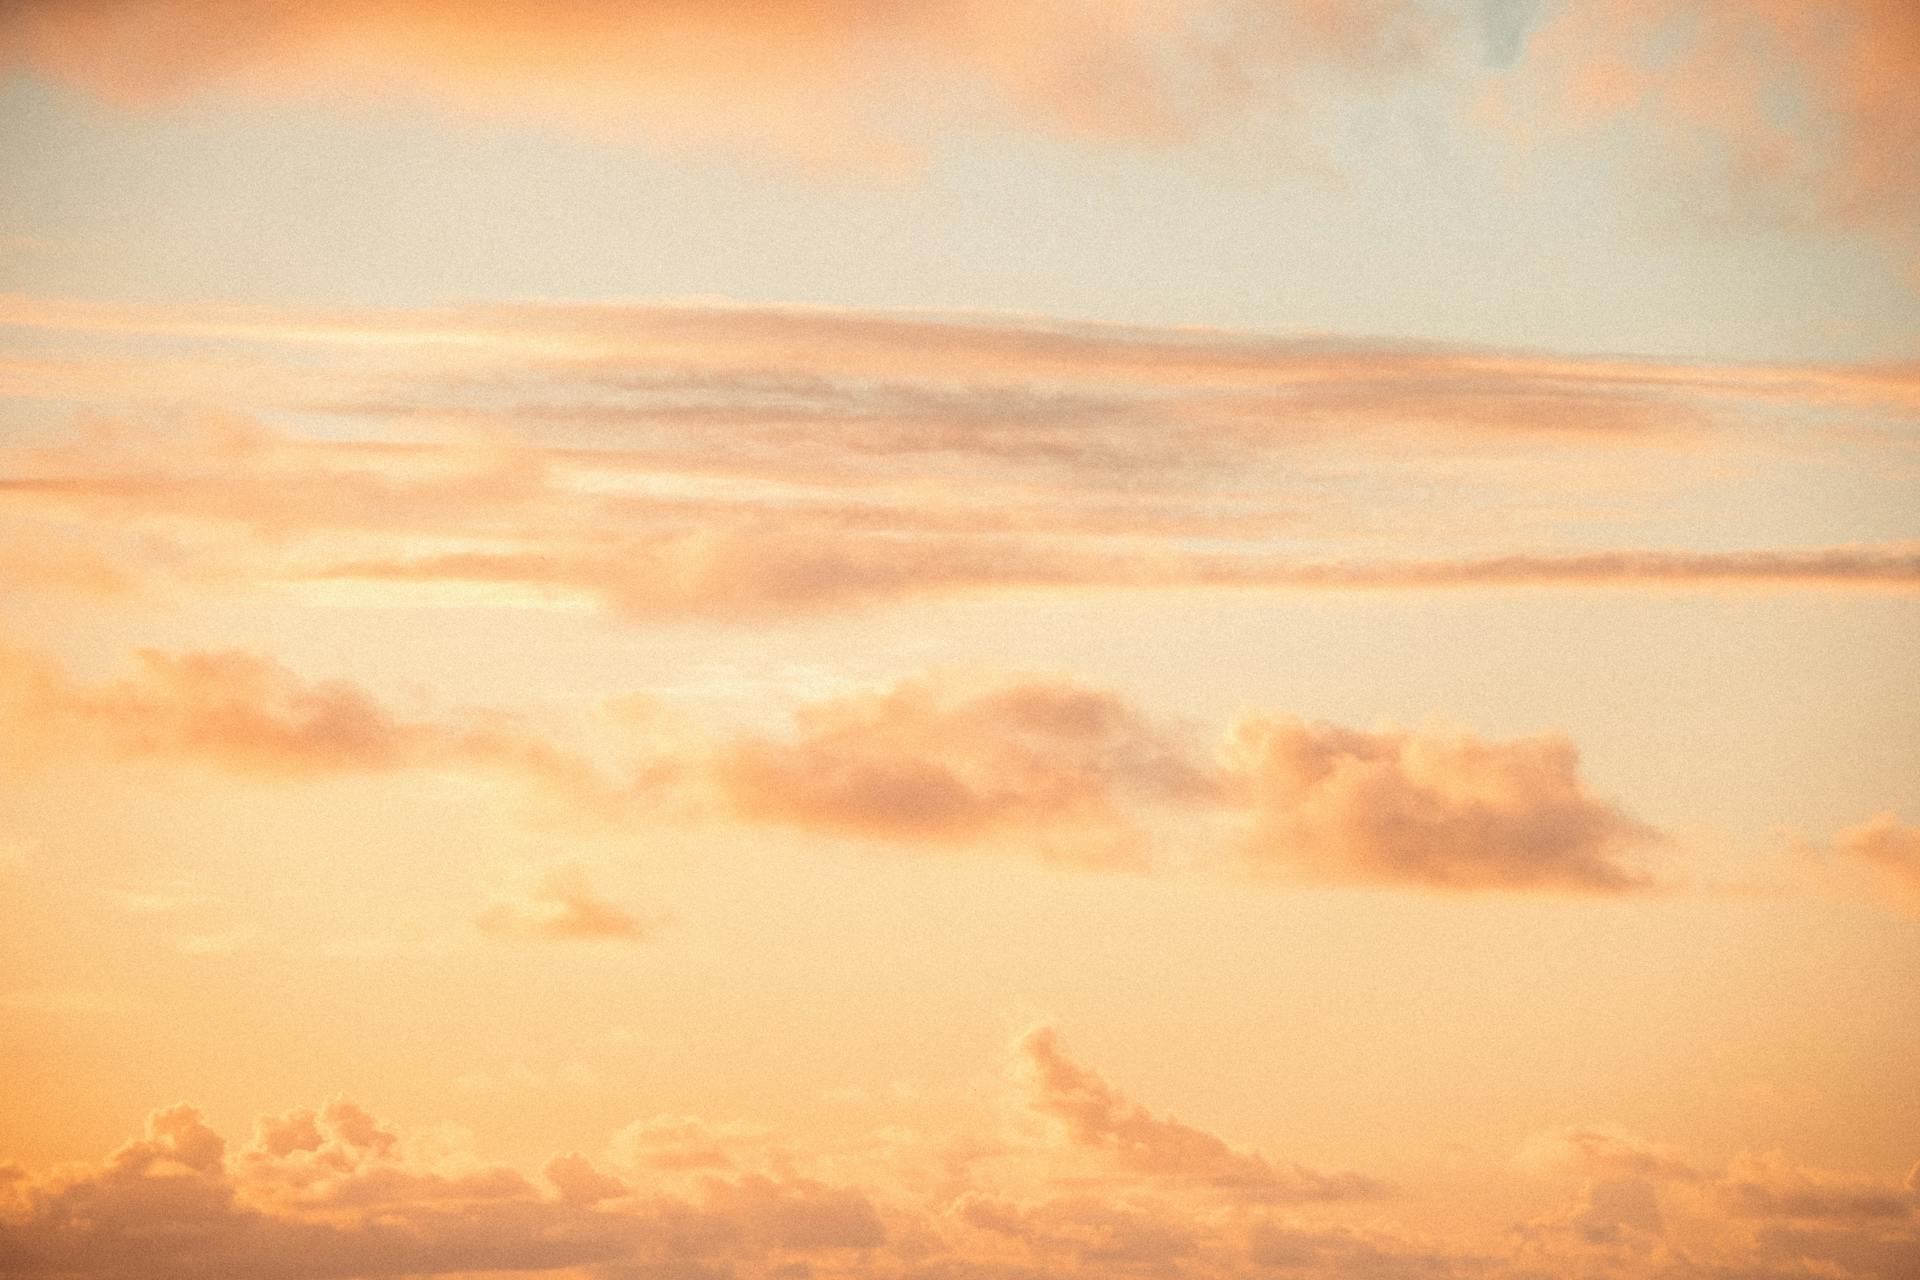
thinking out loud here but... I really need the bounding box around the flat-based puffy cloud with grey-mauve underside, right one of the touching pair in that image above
[1227,716,1655,892]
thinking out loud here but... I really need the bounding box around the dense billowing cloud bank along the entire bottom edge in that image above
[0,1027,1920,1280]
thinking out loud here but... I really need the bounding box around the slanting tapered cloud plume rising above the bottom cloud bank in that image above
[1016,1027,1386,1203]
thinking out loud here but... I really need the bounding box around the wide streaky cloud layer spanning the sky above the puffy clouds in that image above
[0,297,1920,622]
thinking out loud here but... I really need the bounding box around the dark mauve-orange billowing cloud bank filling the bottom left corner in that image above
[0,1100,883,1280]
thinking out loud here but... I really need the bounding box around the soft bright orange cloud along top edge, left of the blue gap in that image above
[0,0,1434,161]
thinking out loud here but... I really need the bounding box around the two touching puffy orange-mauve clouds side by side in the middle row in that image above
[716,679,1657,892]
